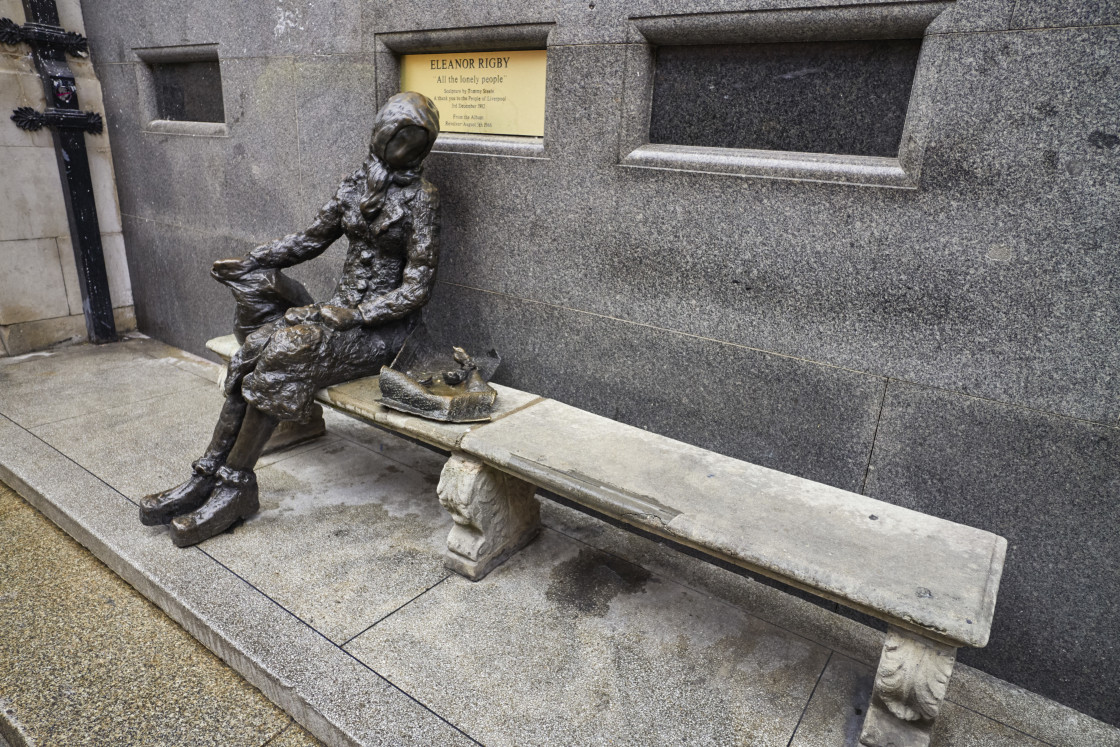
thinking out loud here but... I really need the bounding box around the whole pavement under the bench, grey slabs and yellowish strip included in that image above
[0,336,1120,747]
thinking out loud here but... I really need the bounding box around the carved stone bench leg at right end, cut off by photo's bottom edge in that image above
[859,625,956,747]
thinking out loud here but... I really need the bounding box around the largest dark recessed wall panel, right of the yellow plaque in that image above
[650,39,922,157]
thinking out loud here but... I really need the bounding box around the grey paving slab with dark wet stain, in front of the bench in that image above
[346,530,828,745]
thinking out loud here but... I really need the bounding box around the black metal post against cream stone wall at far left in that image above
[24,0,116,343]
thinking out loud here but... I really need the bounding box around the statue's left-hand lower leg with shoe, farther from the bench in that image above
[140,392,249,526]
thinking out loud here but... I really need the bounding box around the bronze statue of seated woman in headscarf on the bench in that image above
[140,93,439,547]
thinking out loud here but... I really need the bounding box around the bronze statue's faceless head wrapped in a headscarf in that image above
[370,91,439,171]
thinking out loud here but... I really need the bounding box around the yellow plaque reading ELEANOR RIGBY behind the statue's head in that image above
[401,49,547,138]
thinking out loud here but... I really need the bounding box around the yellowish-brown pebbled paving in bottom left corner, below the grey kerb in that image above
[0,484,293,747]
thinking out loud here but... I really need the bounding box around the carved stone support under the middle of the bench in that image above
[436,454,541,581]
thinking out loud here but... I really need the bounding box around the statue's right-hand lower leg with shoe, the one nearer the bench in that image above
[171,405,278,548]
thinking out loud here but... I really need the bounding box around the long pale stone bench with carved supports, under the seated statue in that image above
[207,335,1007,747]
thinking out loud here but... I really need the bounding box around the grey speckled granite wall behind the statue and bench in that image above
[86,0,1120,725]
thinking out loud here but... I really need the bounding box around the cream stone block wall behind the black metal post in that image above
[0,0,136,356]
